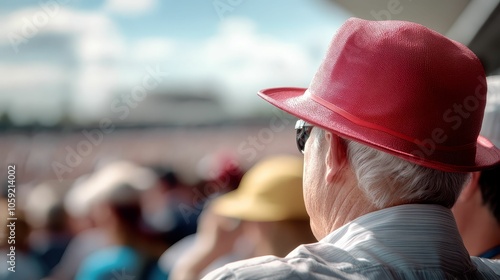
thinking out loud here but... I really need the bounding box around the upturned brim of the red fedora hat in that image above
[258,87,500,172]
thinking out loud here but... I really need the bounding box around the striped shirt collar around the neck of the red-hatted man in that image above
[320,204,474,269]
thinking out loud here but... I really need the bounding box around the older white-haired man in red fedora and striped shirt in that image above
[202,18,500,279]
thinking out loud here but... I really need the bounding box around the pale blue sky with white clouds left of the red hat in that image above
[0,0,349,124]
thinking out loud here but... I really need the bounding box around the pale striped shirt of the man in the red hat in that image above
[203,204,500,280]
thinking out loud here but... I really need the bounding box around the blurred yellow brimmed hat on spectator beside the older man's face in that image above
[212,156,309,222]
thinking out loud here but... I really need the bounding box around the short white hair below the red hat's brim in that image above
[316,130,470,209]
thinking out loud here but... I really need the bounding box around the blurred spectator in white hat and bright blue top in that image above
[41,162,165,279]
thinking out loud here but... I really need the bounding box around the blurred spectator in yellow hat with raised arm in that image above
[168,156,315,279]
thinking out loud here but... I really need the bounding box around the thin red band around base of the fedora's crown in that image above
[304,89,476,151]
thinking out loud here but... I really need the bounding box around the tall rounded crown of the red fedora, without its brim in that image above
[307,19,487,168]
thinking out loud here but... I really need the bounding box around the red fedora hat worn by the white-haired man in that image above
[259,18,500,172]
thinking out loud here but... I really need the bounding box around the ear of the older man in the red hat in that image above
[325,131,347,183]
